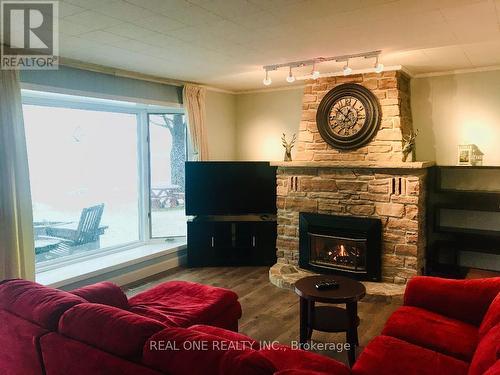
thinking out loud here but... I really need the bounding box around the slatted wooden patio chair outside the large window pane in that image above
[41,204,107,246]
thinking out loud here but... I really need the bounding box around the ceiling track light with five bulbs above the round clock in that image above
[262,51,384,86]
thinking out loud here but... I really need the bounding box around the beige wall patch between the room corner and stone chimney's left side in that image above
[236,88,304,160]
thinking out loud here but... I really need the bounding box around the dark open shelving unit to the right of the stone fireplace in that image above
[426,165,500,278]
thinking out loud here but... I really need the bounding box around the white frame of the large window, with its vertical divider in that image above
[21,88,189,272]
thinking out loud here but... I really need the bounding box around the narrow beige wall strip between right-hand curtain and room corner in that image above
[206,90,236,160]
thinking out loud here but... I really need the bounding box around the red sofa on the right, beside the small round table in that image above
[352,276,500,375]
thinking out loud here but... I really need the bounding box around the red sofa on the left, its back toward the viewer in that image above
[0,280,349,375]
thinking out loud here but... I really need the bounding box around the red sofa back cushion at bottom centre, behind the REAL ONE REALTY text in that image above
[143,328,275,375]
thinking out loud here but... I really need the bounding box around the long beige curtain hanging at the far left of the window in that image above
[0,70,35,280]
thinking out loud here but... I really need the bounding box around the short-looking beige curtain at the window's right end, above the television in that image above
[182,84,208,161]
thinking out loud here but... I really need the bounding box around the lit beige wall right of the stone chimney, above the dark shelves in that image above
[411,70,500,165]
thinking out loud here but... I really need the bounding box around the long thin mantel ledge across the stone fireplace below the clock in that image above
[271,161,435,169]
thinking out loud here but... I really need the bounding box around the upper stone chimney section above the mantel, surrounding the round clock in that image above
[294,71,412,162]
